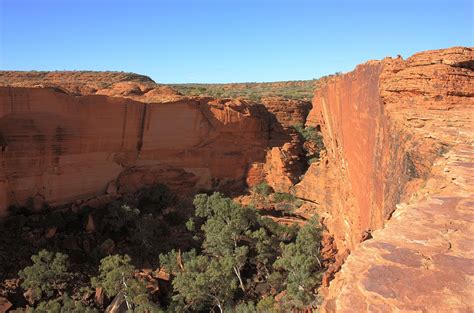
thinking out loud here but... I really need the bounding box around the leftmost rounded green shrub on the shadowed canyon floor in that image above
[18,250,71,297]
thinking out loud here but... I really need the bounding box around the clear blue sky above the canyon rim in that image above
[0,0,474,83]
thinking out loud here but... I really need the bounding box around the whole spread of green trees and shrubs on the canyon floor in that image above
[7,185,322,312]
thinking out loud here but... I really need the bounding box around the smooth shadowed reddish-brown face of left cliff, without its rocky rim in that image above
[0,87,269,215]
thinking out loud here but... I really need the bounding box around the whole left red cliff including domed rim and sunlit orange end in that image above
[0,71,318,216]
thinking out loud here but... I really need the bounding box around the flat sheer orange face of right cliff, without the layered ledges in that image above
[297,62,387,247]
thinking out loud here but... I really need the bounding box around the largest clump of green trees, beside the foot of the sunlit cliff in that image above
[160,193,319,312]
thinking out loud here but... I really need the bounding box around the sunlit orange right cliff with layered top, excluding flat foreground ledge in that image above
[297,48,473,249]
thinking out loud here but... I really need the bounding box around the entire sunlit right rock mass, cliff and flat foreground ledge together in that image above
[297,48,474,312]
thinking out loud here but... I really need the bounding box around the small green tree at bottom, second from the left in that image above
[92,255,148,309]
